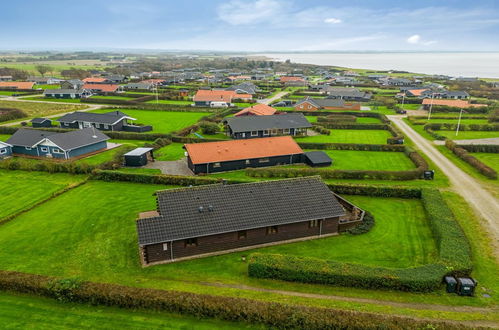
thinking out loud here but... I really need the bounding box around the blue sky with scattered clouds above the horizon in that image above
[0,0,499,52]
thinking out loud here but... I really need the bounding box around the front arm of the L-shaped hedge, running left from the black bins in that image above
[248,253,447,292]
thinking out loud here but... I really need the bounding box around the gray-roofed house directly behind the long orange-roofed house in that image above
[224,113,312,139]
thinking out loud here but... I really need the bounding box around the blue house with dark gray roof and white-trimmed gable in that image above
[7,128,109,159]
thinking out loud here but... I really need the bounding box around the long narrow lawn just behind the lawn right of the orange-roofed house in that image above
[296,129,391,144]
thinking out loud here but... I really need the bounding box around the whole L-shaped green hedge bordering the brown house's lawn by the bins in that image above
[248,186,472,292]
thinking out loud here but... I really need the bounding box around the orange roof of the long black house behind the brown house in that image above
[184,136,303,164]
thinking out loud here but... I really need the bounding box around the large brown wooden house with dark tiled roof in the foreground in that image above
[137,177,364,265]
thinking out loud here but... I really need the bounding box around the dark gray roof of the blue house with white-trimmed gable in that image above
[7,128,109,150]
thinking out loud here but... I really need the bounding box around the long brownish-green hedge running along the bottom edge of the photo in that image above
[0,271,470,330]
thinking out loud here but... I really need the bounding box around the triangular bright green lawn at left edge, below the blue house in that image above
[0,170,84,219]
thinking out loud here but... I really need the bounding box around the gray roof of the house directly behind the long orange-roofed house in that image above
[225,113,312,133]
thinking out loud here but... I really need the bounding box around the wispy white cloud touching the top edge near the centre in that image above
[217,0,281,25]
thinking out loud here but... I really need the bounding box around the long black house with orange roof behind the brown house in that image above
[184,136,303,174]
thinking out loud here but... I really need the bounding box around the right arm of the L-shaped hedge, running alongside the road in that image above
[421,188,472,276]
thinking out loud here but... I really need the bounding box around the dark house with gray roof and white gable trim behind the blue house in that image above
[57,111,152,133]
